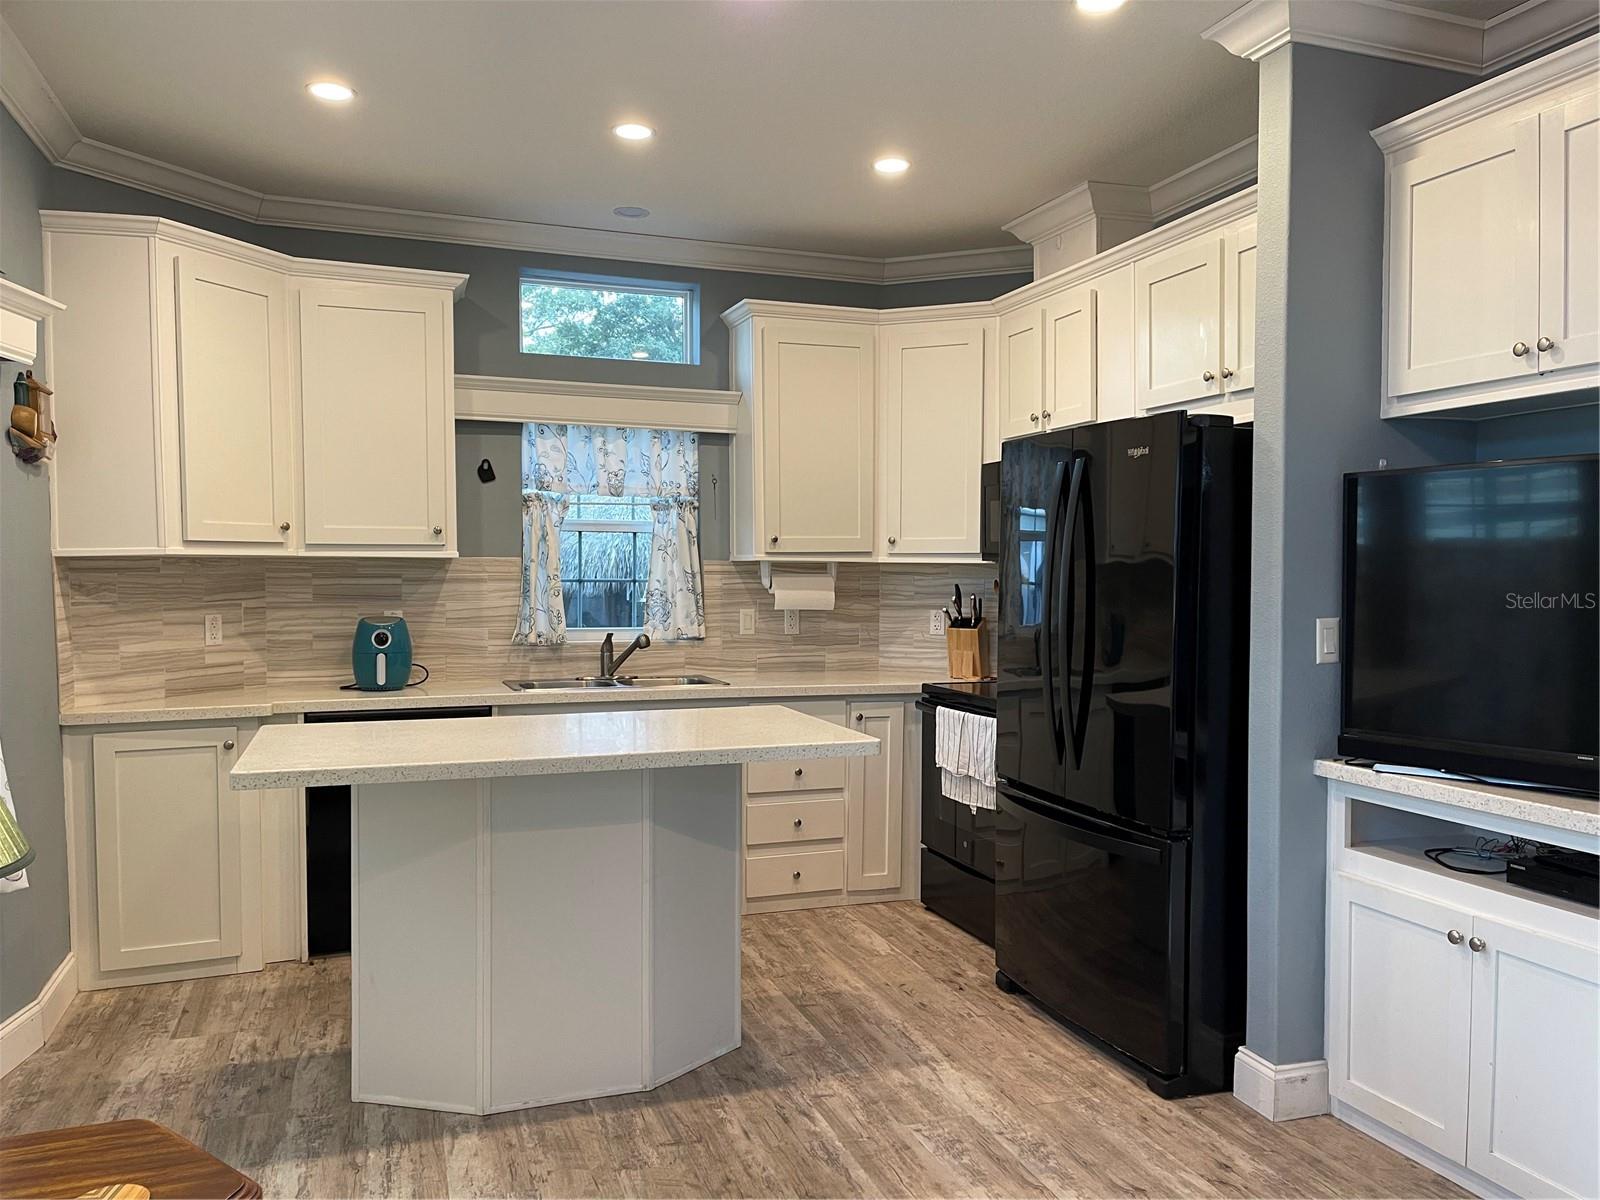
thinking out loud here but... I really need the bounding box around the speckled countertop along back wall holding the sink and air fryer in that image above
[61,667,946,725]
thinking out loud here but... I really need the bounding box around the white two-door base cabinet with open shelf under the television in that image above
[1315,760,1600,1197]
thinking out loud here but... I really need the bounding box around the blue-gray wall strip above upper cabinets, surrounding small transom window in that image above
[50,170,1032,387]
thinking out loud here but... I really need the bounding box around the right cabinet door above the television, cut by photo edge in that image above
[1536,94,1600,371]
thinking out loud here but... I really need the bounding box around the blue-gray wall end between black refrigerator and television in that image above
[1246,45,1474,1062]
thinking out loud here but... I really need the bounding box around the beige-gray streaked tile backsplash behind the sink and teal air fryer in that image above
[56,558,995,706]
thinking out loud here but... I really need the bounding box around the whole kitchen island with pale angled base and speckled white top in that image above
[229,706,878,1114]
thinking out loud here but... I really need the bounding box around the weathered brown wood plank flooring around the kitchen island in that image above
[0,904,1462,1197]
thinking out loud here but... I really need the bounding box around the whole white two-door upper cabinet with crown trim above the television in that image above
[1373,38,1600,418]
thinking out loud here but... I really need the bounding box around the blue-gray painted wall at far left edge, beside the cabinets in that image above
[0,109,72,1021]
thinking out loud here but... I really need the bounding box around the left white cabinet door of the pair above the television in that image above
[1387,117,1539,397]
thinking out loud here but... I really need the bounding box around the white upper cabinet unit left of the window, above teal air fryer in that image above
[42,213,466,557]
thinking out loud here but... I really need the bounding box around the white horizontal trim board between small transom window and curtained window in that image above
[456,374,742,434]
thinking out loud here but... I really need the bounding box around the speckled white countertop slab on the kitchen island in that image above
[229,704,878,790]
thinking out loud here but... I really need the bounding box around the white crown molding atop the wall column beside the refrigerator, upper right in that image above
[1202,0,1600,75]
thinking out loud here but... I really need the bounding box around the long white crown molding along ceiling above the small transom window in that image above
[0,18,1032,285]
